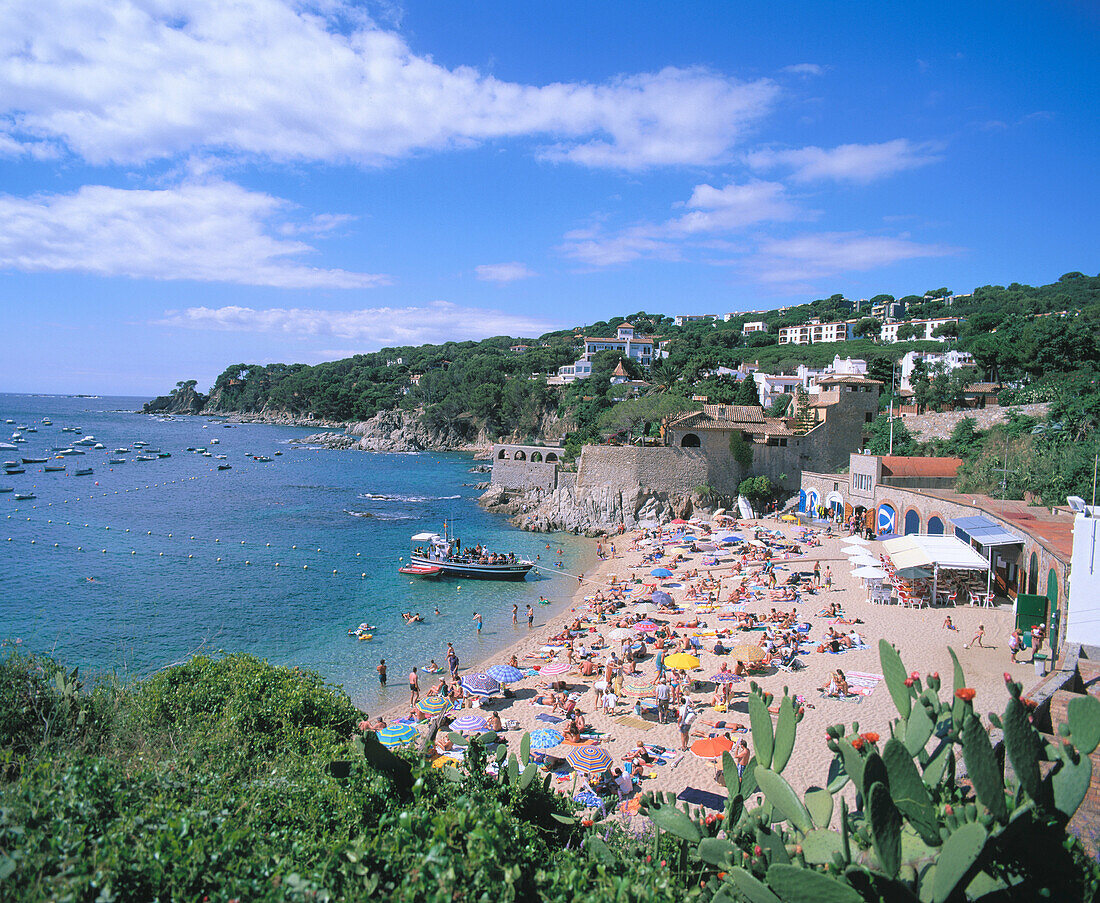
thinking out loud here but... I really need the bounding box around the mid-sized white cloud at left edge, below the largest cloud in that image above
[0,180,387,288]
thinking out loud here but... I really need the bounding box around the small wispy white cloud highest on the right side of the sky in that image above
[747,137,939,184]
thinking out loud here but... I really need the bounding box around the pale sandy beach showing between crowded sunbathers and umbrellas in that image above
[374,519,1036,795]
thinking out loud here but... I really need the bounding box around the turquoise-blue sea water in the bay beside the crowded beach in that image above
[0,395,592,713]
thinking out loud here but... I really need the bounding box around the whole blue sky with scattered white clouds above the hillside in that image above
[0,0,1100,395]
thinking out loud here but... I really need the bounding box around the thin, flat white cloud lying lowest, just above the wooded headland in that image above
[154,301,560,351]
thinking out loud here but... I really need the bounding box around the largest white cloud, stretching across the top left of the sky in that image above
[0,0,779,169]
